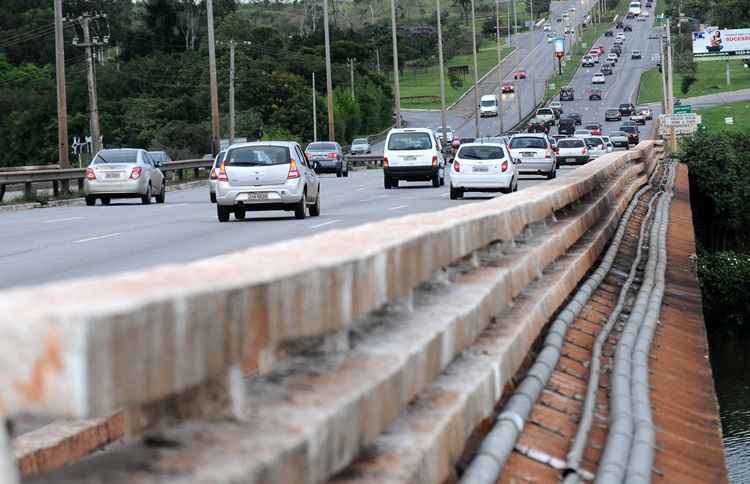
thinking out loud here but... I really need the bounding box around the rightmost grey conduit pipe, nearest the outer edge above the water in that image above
[625,167,675,484]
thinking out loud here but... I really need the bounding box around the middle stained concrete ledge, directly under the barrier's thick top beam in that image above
[27,156,643,483]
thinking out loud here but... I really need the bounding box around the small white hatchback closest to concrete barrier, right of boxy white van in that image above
[450,143,518,200]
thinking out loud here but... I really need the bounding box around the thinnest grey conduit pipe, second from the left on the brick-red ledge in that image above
[563,183,659,484]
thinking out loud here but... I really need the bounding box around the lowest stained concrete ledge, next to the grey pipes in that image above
[329,168,647,484]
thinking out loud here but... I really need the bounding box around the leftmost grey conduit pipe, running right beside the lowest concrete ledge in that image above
[460,174,653,484]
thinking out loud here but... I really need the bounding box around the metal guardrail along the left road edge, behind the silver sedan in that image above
[0,159,213,202]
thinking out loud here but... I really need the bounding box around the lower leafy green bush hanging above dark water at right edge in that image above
[697,251,750,327]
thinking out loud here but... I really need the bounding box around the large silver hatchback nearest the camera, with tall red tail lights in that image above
[216,141,320,222]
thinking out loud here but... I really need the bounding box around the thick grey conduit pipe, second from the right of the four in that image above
[595,164,680,484]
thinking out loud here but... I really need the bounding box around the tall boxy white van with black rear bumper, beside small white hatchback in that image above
[383,128,445,190]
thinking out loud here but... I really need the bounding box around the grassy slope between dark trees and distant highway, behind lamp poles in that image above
[400,47,513,109]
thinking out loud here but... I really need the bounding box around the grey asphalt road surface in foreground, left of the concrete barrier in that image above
[0,164,573,296]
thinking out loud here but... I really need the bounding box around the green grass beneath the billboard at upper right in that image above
[638,60,750,103]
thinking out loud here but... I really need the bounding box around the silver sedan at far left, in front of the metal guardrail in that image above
[83,148,167,206]
